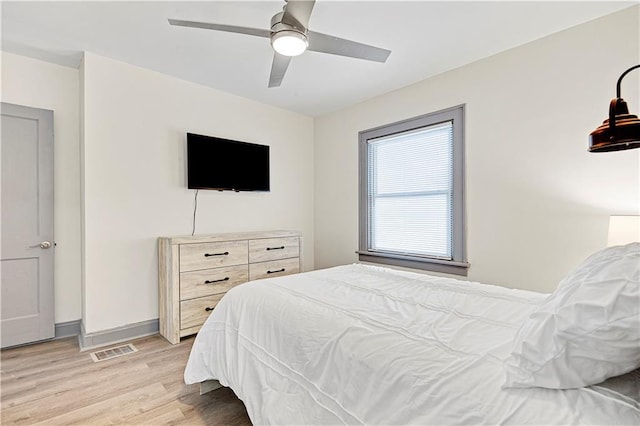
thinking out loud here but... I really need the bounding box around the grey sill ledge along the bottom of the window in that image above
[356,251,470,277]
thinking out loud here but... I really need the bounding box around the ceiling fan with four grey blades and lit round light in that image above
[169,0,391,87]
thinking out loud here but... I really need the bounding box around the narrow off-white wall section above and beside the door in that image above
[1,52,81,323]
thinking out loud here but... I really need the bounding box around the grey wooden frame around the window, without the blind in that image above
[357,104,469,276]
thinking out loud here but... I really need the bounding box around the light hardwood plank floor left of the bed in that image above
[0,335,251,425]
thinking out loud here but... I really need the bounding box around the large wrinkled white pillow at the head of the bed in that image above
[504,243,640,389]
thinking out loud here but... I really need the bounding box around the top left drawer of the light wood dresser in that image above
[180,241,248,272]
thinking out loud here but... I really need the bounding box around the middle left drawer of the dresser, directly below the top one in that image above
[180,265,249,300]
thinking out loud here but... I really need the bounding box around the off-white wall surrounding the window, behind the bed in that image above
[314,7,640,292]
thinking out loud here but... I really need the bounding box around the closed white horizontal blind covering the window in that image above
[367,121,453,260]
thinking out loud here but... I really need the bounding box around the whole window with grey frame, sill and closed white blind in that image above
[358,106,469,275]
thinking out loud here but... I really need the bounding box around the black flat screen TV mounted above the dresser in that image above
[187,133,270,192]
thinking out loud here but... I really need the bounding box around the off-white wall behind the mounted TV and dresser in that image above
[82,53,314,333]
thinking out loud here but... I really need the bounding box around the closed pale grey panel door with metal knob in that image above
[0,103,55,348]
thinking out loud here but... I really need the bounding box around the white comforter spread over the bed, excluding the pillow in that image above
[184,265,640,425]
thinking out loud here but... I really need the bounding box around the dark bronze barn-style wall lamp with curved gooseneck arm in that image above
[589,65,640,152]
